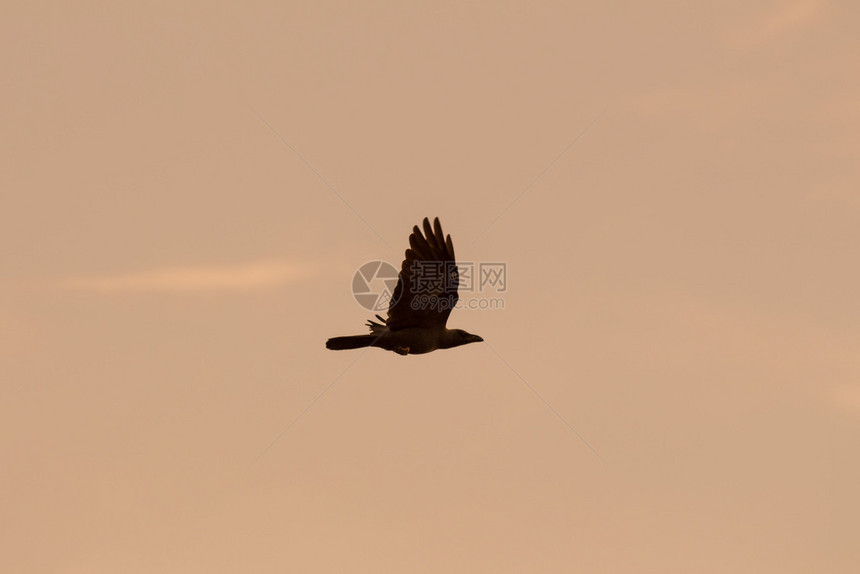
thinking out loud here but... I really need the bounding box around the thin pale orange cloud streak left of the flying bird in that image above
[61,260,313,293]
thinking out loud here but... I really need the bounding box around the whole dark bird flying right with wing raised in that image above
[325,217,483,355]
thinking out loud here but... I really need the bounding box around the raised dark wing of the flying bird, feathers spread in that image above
[387,217,460,331]
